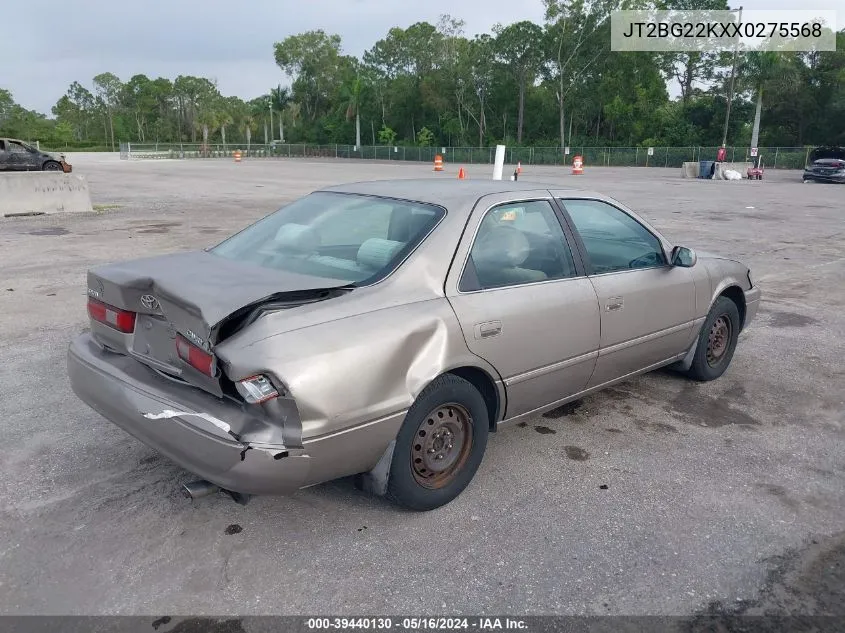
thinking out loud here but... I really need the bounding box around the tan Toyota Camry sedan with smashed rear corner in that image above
[68,178,760,510]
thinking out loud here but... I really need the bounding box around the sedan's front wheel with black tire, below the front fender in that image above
[687,297,740,382]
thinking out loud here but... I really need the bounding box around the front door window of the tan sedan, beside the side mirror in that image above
[561,200,666,274]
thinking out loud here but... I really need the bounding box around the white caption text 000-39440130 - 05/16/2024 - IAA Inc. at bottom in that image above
[305,617,528,631]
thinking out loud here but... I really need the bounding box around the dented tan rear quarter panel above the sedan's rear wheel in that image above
[216,298,498,440]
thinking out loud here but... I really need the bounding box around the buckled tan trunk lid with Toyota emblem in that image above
[88,251,349,396]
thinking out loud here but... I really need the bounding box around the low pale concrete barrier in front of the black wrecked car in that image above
[0,171,93,217]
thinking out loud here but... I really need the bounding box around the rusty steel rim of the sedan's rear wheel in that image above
[411,403,472,490]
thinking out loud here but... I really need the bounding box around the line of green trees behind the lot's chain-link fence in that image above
[0,0,845,148]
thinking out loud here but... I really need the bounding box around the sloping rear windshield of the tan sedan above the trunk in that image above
[209,192,445,285]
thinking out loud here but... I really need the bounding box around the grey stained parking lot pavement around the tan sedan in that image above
[0,155,845,616]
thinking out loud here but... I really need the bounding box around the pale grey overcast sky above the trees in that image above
[0,0,845,114]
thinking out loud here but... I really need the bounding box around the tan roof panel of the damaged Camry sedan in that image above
[319,177,607,208]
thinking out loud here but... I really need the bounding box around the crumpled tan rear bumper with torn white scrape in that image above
[67,333,312,494]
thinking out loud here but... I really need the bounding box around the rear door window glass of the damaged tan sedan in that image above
[460,200,576,291]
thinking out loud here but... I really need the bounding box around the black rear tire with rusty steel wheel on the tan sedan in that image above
[385,374,490,511]
